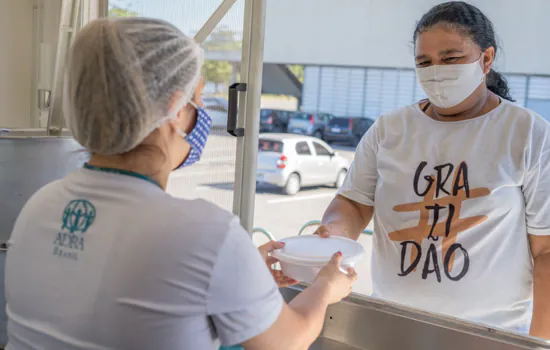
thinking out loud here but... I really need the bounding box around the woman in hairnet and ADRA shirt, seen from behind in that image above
[6,18,356,350]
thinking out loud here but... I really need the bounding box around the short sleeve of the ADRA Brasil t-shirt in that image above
[207,220,284,346]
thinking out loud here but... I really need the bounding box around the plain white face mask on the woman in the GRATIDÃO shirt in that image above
[416,58,485,108]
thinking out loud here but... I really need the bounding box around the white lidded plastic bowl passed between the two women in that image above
[272,235,365,283]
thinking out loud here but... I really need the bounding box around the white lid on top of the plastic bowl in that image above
[273,235,365,265]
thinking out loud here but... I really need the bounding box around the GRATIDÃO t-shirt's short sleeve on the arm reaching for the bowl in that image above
[338,122,378,206]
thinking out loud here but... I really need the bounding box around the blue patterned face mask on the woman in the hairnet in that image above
[176,103,212,169]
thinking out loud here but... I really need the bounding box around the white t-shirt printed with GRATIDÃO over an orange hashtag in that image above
[340,101,550,332]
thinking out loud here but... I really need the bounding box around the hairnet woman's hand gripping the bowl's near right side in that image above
[312,253,357,304]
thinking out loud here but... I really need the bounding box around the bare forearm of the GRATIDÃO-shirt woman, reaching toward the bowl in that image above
[322,196,373,240]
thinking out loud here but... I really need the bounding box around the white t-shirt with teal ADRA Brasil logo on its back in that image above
[6,169,283,350]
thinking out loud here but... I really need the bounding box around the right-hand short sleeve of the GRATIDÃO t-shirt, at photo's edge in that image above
[523,120,550,236]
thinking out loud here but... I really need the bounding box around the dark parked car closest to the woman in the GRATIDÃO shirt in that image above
[325,117,374,146]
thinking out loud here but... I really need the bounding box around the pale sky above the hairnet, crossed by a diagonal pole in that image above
[109,0,244,35]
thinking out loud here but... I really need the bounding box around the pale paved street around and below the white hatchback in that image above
[169,133,371,293]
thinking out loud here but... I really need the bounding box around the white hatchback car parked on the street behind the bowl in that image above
[256,134,350,195]
